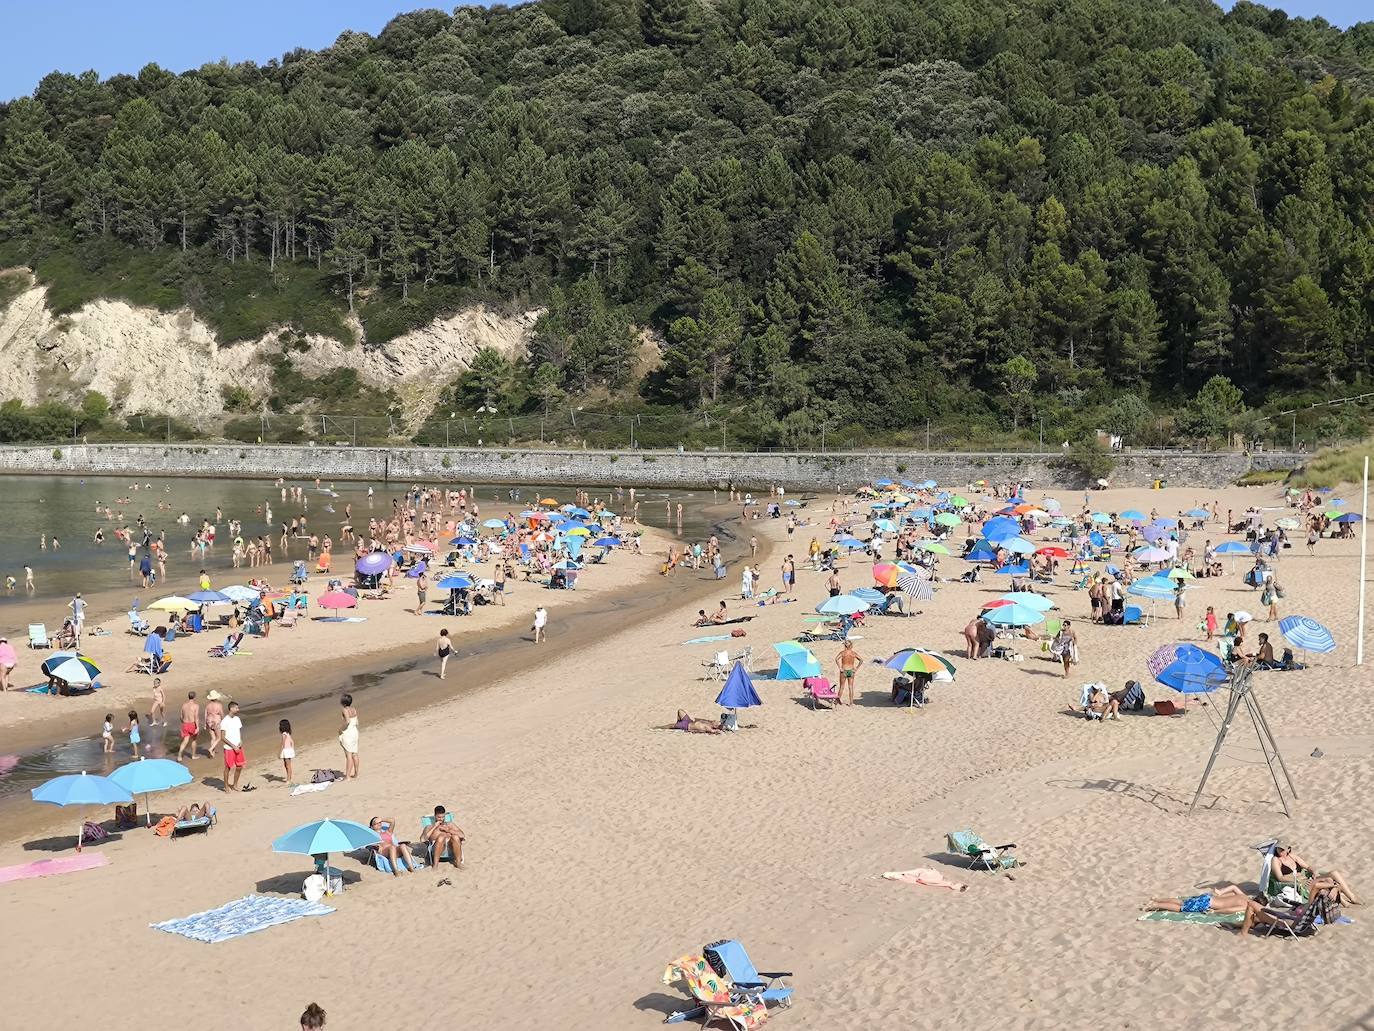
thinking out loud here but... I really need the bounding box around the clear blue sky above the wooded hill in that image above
[0,0,1374,100]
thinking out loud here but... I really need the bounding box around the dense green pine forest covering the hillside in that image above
[0,0,1374,444]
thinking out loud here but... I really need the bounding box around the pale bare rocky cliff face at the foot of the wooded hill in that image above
[0,271,543,430]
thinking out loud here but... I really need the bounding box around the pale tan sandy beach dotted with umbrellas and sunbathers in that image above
[0,487,1374,1031]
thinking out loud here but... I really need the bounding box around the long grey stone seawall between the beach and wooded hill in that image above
[0,444,1308,491]
